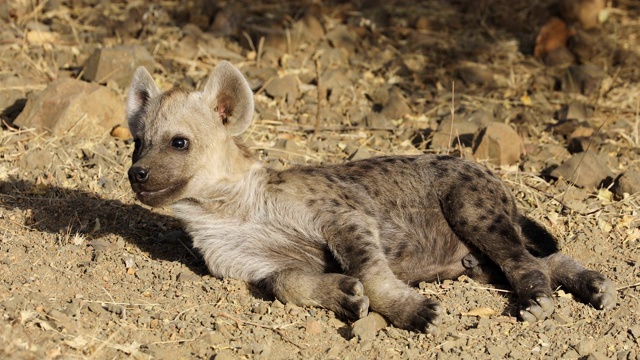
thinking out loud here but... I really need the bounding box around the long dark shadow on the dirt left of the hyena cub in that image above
[0,180,209,276]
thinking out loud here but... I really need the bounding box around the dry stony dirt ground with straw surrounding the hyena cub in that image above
[0,0,640,360]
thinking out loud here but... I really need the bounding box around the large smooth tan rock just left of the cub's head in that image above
[14,78,125,136]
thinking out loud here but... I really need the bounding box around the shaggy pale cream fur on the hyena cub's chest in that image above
[172,167,326,282]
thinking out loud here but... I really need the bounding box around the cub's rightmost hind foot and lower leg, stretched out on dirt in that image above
[542,253,617,310]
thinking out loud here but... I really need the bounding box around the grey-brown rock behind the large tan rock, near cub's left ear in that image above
[82,45,155,89]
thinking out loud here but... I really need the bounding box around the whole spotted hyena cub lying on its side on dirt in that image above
[127,62,616,332]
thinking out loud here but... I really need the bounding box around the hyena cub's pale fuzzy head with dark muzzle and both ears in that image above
[126,61,253,206]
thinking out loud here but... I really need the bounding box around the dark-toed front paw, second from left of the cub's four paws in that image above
[387,296,442,335]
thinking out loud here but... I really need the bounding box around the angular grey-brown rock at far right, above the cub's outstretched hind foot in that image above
[551,150,613,188]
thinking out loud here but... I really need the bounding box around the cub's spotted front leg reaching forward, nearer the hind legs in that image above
[325,211,442,333]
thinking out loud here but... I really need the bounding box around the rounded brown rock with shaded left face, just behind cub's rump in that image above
[473,122,522,165]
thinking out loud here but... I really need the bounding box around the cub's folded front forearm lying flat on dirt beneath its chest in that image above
[258,267,369,320]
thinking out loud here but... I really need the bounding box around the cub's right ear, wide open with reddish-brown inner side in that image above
[203,61,253,136]
